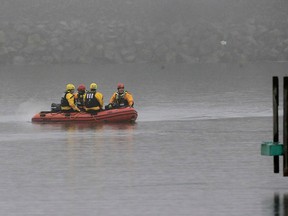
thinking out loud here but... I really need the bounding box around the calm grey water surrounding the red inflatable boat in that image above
[0,63,288,216]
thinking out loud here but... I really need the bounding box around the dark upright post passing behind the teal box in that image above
[272,77,279,173]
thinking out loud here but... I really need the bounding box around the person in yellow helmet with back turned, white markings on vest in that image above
[84,83,104,114]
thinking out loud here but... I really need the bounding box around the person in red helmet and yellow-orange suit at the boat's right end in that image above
[105,83,134,109]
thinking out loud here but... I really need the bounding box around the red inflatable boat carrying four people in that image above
[32,107,138,123]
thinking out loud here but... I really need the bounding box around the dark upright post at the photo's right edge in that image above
[283,77,288,176]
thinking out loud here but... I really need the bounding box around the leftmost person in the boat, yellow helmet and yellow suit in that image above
[61,84,80,112]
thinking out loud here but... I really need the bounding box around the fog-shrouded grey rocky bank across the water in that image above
[0,0,288,64]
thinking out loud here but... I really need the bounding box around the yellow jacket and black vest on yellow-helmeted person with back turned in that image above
[84,91,104,111]
